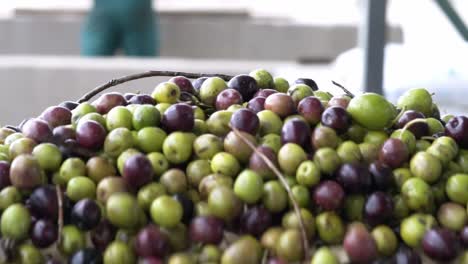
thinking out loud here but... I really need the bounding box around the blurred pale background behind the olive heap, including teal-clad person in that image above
[0,0,468,125]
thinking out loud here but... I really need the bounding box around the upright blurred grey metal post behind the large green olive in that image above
[359,0,387,94]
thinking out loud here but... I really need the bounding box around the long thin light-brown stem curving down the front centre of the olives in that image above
[229,125,309,261]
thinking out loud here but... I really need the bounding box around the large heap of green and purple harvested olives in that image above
[0,70,468,264]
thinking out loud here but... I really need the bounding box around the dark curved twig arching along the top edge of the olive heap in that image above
[77,71,238,103]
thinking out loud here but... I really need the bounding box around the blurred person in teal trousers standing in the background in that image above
[81,0,159,56]
